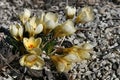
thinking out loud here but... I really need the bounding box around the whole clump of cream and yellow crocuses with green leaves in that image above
[10,6,94,72]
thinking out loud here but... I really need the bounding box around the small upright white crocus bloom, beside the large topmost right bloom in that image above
[65,6,76,19]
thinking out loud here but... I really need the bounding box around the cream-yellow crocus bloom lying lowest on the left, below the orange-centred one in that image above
[20,54,45,70]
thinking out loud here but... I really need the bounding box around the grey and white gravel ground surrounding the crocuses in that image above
[0,0,120,80]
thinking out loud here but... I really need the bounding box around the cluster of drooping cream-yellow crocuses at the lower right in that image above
[51,43,93,72]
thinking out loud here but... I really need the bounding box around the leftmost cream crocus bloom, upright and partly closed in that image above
[10,24,23,41]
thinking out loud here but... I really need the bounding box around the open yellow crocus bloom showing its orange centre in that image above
[23,37,42,51]
